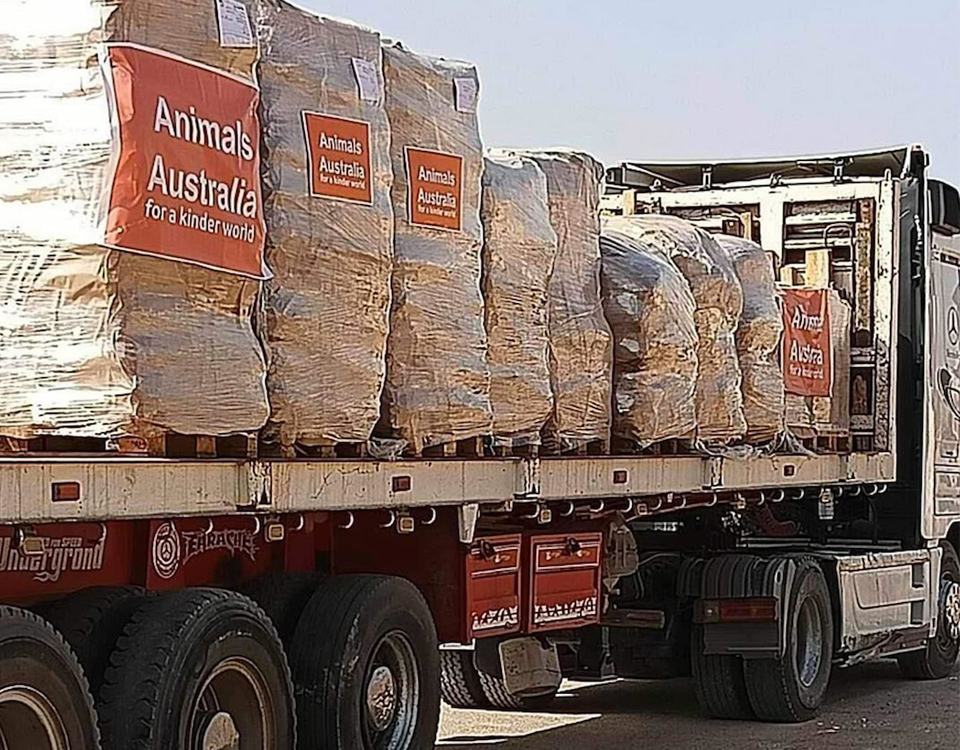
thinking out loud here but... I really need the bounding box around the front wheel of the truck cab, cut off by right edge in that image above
[897,541,960,680]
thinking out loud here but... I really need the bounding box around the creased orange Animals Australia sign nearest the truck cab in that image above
[783,289,833,396]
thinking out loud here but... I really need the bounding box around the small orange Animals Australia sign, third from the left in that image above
[405,146,463,230]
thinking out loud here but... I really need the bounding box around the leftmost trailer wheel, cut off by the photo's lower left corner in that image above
[0,606,100,750]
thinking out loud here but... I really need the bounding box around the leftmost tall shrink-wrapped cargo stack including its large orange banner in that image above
[0,0,267,453]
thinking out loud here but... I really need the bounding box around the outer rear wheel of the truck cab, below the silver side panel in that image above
[743,560,833,722]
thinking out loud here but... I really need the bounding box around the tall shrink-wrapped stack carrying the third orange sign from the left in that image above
[383,44,493,452]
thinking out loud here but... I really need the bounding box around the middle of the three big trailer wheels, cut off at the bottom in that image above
[100,588,296,750]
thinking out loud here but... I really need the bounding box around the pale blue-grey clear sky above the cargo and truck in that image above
[306,0,960,185]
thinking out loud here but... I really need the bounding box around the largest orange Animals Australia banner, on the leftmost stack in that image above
[104,44,268,278]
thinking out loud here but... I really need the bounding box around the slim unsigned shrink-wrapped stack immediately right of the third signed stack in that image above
[480,151,557,448]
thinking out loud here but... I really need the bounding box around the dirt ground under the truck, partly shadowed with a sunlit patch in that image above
[437,661,960,750]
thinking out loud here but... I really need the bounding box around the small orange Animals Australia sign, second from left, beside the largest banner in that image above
[303,112,373,205]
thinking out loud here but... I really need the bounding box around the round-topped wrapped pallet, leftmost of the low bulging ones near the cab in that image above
[600,217,697,448]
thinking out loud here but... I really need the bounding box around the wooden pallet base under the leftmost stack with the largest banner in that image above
[0,433,257,458]
